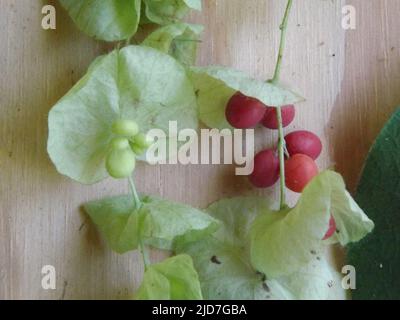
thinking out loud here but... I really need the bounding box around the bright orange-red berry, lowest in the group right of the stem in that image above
[285,154,318,193]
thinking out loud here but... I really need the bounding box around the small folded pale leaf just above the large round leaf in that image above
[142,23,203,65]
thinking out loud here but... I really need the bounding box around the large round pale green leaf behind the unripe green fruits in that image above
[48,46,198,184]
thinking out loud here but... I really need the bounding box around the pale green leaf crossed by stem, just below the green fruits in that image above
[85,196,219,253]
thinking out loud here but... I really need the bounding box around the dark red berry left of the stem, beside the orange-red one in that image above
[249,149,279,188]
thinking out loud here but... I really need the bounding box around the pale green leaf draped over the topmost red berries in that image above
[190,66,304,129]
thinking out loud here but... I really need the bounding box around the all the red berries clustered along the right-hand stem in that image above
[225,92,336,240]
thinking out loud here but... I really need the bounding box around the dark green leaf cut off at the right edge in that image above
[348,109,400,300]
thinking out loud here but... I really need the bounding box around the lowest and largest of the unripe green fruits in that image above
[106,147,136,179]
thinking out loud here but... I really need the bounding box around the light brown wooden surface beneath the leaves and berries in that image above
[0,0,400,299]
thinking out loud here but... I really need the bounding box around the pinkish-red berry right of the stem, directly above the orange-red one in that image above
[285,131,322,160]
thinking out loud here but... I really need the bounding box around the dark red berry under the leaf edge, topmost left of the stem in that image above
[225,92,266,129]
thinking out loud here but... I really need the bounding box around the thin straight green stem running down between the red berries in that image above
[269,0,293,210]
